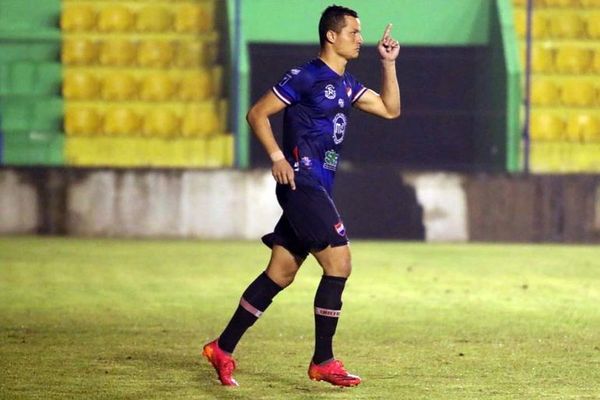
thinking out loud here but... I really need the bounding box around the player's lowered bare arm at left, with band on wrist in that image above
[246,91,296,190]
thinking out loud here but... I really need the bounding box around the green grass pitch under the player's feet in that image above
[0,237,600,400]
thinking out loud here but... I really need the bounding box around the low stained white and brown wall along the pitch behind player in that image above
[0,168,600,243]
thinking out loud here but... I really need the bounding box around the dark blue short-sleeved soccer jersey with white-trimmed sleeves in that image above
[273,58,367,195]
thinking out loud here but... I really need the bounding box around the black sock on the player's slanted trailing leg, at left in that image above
[219,272,282,353]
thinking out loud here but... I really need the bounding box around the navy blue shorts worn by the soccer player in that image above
[262,181,348,259]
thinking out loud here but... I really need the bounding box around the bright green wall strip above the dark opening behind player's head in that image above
[241,0,491,46]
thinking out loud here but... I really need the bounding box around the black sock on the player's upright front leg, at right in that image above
[313,275,346,364]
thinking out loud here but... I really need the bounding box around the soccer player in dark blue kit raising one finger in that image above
[203,6,400,386]
